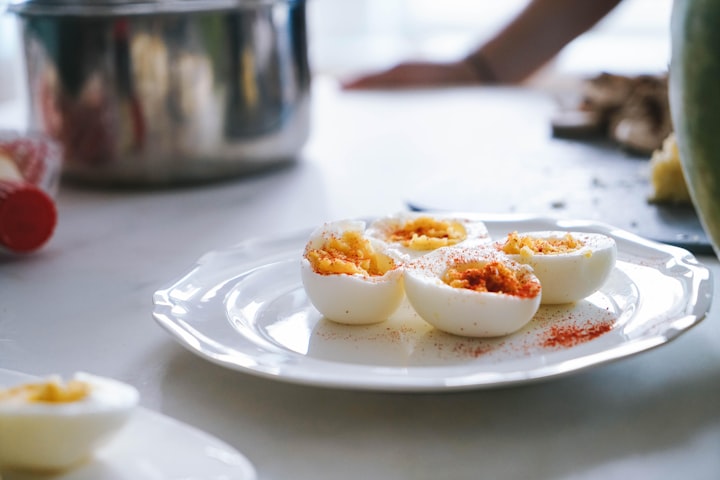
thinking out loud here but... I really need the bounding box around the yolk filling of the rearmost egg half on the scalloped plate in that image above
[388,217,467,250]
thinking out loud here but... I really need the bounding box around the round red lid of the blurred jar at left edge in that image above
[0,180,57,253]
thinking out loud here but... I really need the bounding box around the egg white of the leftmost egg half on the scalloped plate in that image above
[300,220,404,325]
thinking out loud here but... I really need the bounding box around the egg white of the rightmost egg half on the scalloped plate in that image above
[496,231,617,304]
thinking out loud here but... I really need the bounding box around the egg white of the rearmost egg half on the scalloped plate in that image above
[366,212,491,261]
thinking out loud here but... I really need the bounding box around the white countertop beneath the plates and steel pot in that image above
[0,79,720,480]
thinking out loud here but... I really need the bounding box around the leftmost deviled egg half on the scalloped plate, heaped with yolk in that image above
[300,220,404,325]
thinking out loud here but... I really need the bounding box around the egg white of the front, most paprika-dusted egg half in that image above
[404,247,541,337]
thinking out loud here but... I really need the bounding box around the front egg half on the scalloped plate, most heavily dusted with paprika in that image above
[404,247,541,337]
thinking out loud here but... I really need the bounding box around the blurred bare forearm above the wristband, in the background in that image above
[467,0,620,83]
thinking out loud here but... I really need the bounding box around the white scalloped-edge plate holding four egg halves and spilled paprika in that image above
[153,215,712,391]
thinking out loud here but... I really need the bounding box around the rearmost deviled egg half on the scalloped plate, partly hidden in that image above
[366,212,490,260]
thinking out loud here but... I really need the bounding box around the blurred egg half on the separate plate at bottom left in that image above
[0,373,139,472]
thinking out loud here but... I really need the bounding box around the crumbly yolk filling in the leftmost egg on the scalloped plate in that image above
[305,231,395,276]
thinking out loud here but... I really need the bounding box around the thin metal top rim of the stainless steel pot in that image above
[7,0,304,17]
